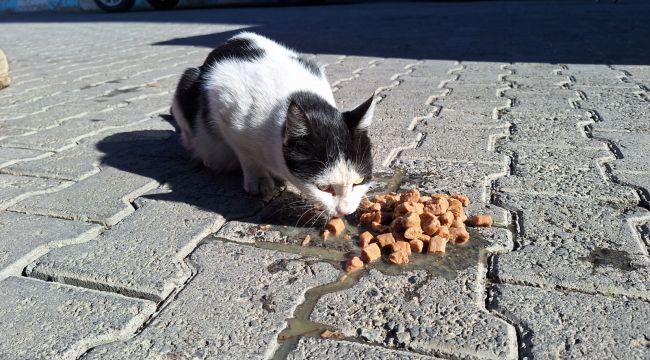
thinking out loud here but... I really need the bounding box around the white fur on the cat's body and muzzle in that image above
[172,32,372,215]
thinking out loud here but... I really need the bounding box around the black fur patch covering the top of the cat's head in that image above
[283,92,372,183]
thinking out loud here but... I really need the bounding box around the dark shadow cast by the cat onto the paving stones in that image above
[96,115,320,226]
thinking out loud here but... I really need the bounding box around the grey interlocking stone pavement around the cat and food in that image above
[0,1,650,359]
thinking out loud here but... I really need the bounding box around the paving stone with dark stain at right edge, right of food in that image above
[491,194,650,299]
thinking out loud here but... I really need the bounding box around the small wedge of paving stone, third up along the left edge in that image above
[0,174,71,210]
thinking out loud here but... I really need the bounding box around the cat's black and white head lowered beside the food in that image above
[283,92,374,216]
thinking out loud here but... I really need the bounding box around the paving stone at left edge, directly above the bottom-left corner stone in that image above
[0,211,101,279]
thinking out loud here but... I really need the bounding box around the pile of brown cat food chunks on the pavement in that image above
[323,189,492,271]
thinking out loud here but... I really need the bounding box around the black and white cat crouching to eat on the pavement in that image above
[172,32,374,216]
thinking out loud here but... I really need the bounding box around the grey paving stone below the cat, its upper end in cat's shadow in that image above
[27,175,262,301]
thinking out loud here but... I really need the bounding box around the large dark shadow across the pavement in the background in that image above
[1,0,650,65]
